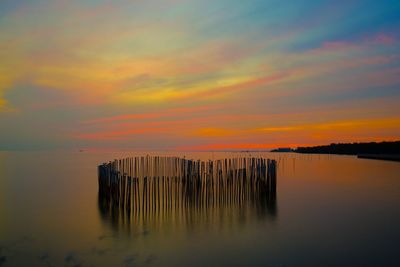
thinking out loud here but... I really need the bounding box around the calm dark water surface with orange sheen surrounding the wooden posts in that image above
[0,152,400,266]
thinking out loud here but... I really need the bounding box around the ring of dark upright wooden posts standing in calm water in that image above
[98,156,277,226]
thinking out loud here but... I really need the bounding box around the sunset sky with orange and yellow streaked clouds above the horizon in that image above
[0,0,400,150]
